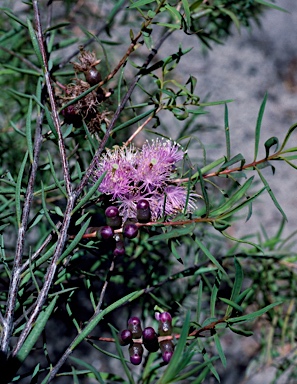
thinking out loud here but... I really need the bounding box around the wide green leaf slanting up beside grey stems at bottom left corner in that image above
[16,296,58,364]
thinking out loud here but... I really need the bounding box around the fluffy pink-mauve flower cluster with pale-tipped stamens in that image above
[94,139,197,221]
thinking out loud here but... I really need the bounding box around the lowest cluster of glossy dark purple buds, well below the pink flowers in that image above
[118,312,174,365]
